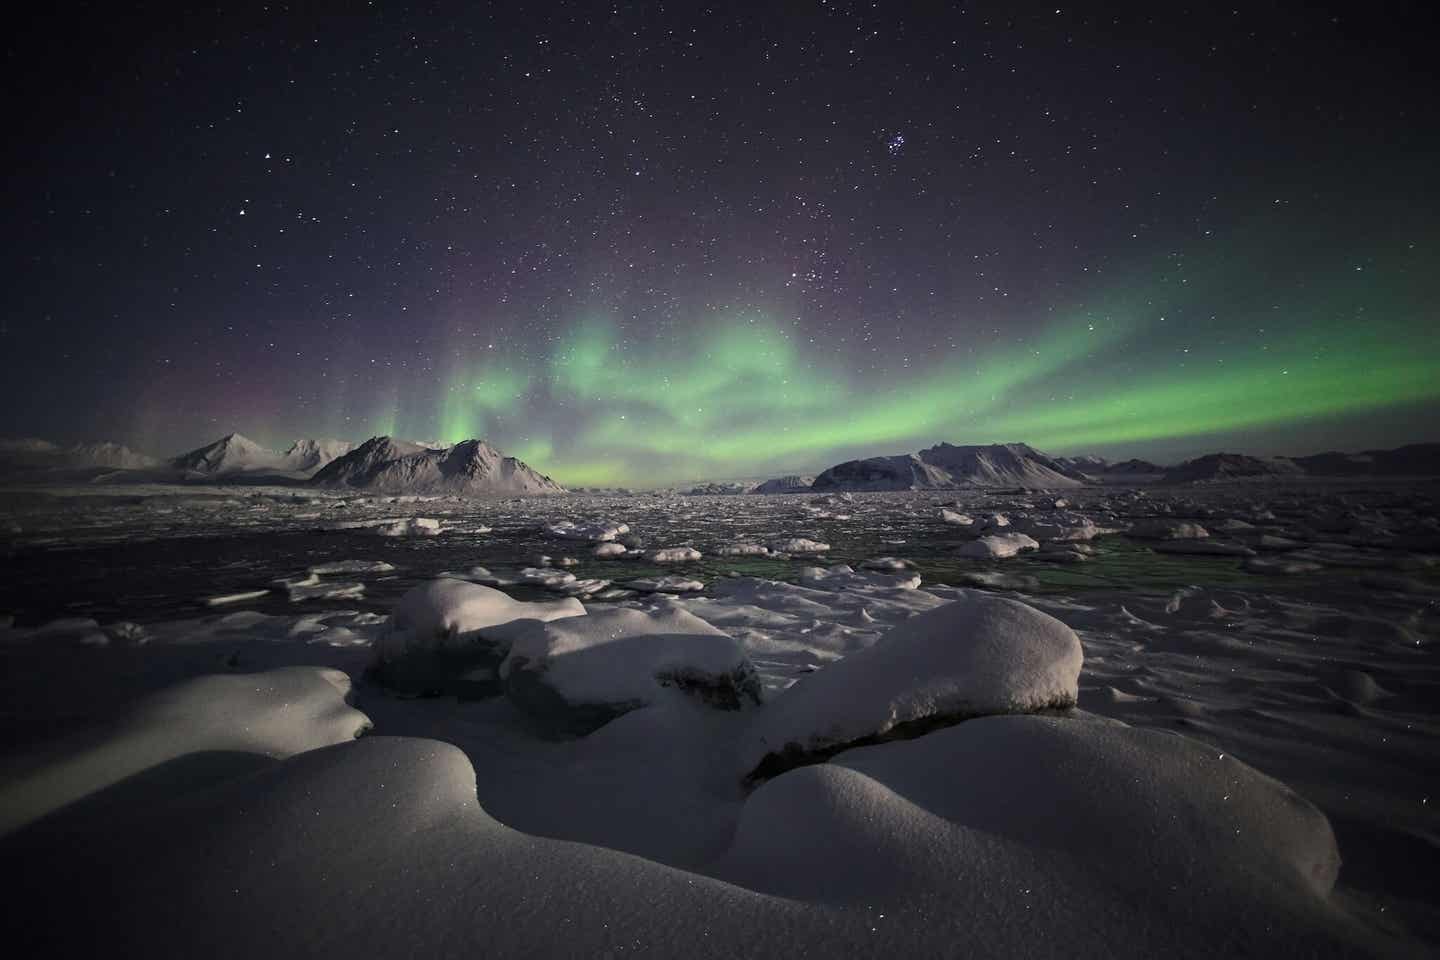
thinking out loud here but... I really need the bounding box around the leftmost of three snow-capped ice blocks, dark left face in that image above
[370,577,585,695]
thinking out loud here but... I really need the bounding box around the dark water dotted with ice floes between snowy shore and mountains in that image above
[0,494,1416,626]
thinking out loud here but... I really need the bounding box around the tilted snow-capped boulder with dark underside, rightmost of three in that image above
[740,590,1083,780]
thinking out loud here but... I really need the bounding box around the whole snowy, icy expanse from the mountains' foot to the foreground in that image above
[0,481,1440,957]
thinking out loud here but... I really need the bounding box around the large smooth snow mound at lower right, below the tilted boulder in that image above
[717,717,1339,915]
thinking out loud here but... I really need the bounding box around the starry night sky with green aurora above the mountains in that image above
[0,1,1440,486]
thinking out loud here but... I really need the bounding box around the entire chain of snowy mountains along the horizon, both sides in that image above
[0,433,1440,495]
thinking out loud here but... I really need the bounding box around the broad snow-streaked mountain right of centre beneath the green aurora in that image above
[811,443,1086,491]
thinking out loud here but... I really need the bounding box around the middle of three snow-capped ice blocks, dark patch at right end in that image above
[495,604,760,735]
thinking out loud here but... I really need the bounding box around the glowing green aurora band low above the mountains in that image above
[331,236,1440,486]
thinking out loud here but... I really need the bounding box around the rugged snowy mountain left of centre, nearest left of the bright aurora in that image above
[311,436,564,497]
